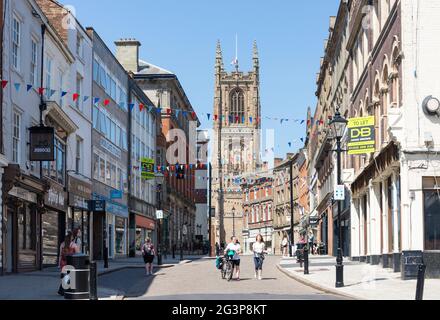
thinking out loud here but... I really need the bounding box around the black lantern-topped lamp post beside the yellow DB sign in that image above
[330,108,348,288]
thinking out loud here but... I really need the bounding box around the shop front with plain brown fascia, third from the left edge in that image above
[67,175,92,255]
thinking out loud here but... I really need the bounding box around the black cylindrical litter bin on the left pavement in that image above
[62,254,90,300]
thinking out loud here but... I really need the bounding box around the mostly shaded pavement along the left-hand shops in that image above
[0,256,200,300]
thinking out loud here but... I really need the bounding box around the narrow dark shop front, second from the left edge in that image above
[42,181,67,267]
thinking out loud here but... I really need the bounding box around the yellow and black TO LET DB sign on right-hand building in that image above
[347,116,376,155]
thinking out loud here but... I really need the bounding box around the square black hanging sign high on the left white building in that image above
[29,127,55,161]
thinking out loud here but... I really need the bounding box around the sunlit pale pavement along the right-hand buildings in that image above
[278,256,440,300]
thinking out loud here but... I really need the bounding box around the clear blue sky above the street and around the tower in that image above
[66,0,339,157]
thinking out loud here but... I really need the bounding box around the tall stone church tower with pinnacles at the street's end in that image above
[212,42,261,243]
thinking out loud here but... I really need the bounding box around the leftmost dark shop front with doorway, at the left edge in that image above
[2,165,46,273]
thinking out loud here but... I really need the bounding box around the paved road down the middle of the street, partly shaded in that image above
[99,257,342,300]
